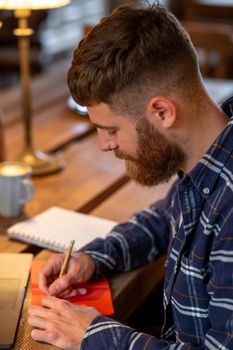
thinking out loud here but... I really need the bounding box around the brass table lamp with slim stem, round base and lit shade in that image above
[0,0,70,175]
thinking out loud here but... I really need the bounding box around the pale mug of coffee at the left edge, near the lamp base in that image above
[0,161,34,217]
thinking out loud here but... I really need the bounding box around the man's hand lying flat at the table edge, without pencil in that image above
[28,296,99,350]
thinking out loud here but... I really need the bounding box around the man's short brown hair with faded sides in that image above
[68,4,200,115]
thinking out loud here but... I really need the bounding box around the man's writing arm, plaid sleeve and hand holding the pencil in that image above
[38,180,175,297]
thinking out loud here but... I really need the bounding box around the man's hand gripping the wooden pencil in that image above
[38,252,95,298]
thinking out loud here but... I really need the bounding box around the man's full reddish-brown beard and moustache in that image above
[114,118,186,186]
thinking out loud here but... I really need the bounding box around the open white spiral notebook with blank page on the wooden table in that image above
[7,207,116,252]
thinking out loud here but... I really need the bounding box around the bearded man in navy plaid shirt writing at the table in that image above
[29,4,233,350]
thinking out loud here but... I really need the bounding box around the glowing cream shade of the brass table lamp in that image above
[0,0,70,10]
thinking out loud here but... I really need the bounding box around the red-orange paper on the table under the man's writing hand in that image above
[31,260,114,315]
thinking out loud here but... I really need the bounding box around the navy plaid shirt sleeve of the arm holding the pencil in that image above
[80,180,175,276]
